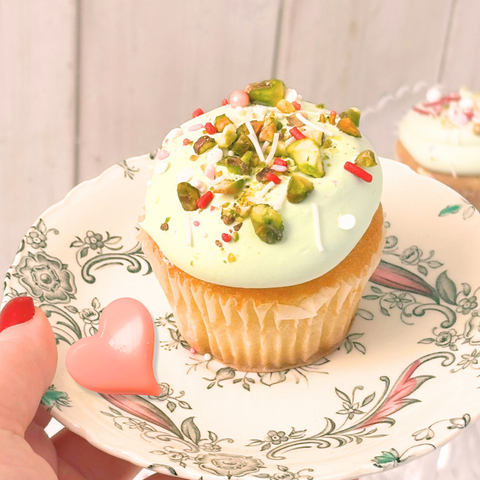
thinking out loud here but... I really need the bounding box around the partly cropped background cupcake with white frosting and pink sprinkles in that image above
[396,87,480,209]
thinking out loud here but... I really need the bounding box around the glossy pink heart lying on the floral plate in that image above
[65,298,161,395]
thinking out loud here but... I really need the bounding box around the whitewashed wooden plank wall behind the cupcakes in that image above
[0,0,480,478]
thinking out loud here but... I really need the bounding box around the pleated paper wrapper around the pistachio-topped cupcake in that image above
[139,227,385,372]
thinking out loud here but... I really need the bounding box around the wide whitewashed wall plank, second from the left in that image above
[79,0,279,180]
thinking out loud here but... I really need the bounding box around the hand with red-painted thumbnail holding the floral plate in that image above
[0,297,167,480]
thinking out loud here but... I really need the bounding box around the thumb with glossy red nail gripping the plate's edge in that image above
[0,297,57,436]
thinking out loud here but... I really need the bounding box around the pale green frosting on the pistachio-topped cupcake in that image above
[141,98,382,288]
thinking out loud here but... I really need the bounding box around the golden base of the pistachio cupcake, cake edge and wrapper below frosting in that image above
[139,206,384,372]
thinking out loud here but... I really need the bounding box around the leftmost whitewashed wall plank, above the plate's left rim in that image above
[0,0,76,278]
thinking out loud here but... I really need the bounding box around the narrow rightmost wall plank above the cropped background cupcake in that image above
[439,0,480,92]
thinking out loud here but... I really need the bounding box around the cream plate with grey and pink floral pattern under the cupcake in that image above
[5,156,480,480]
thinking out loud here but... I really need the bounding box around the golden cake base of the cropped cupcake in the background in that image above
[395,141,480,210]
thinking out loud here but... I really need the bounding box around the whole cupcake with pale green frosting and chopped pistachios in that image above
[140,80,383,372]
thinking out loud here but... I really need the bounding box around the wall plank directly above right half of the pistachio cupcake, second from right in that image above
[277,0,452,115]
